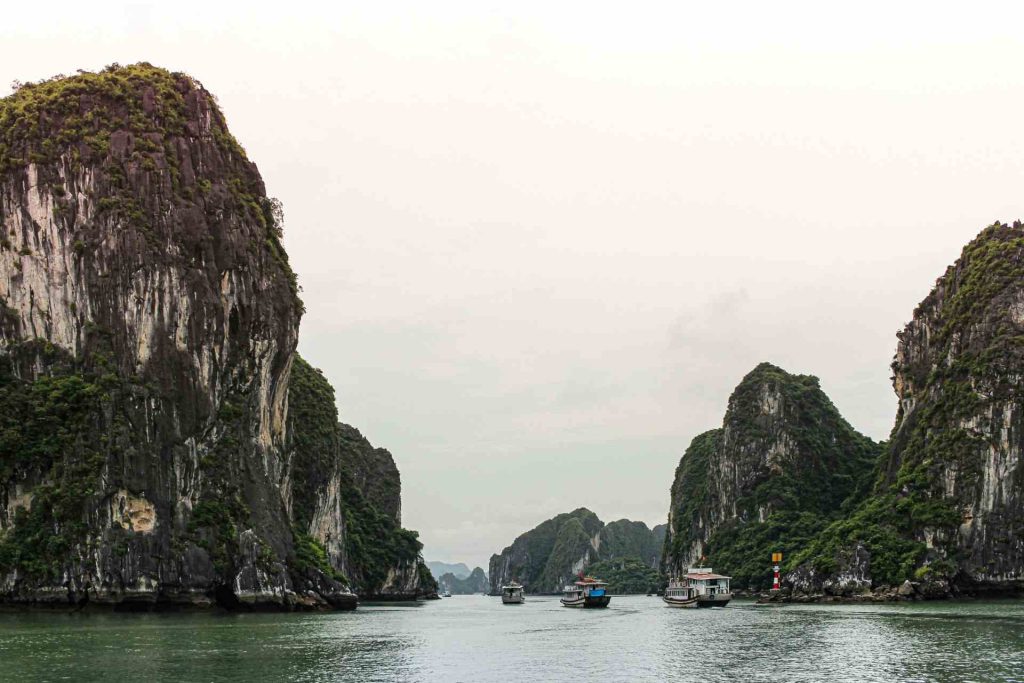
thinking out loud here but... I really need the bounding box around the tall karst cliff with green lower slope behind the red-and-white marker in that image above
[786,222,1024,594]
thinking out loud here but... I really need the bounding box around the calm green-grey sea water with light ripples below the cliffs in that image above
[0,596,1024,683]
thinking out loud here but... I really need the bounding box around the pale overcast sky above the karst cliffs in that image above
[0,0,1024,567]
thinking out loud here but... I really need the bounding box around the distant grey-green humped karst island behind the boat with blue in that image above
[487,508,664,594]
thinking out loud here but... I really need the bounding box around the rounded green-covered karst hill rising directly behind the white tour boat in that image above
[663,364,879,588]
